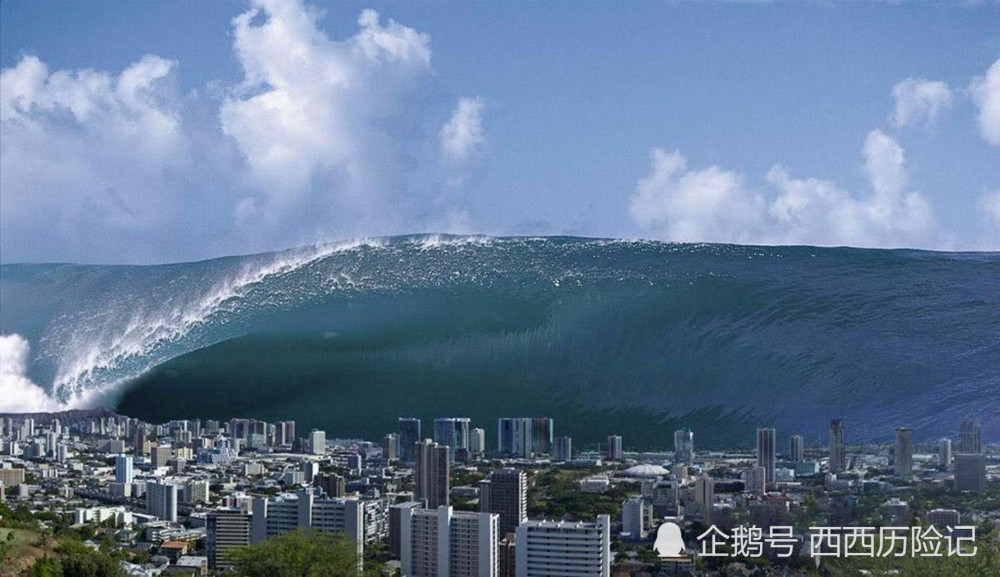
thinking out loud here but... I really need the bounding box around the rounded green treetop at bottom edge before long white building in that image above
[228,530,377,577]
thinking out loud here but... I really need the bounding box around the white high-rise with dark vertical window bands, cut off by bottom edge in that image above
[400,506,500,577]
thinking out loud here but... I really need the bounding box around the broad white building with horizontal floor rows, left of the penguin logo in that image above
[514,515,612,577]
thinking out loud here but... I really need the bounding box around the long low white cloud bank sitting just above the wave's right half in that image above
[629,130,944,247]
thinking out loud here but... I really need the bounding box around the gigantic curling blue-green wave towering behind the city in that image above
[0,236,1000,448]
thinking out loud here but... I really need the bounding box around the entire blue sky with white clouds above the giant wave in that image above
[0,0,1000,263]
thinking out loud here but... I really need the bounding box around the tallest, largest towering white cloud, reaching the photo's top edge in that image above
[220,0,431,232]
